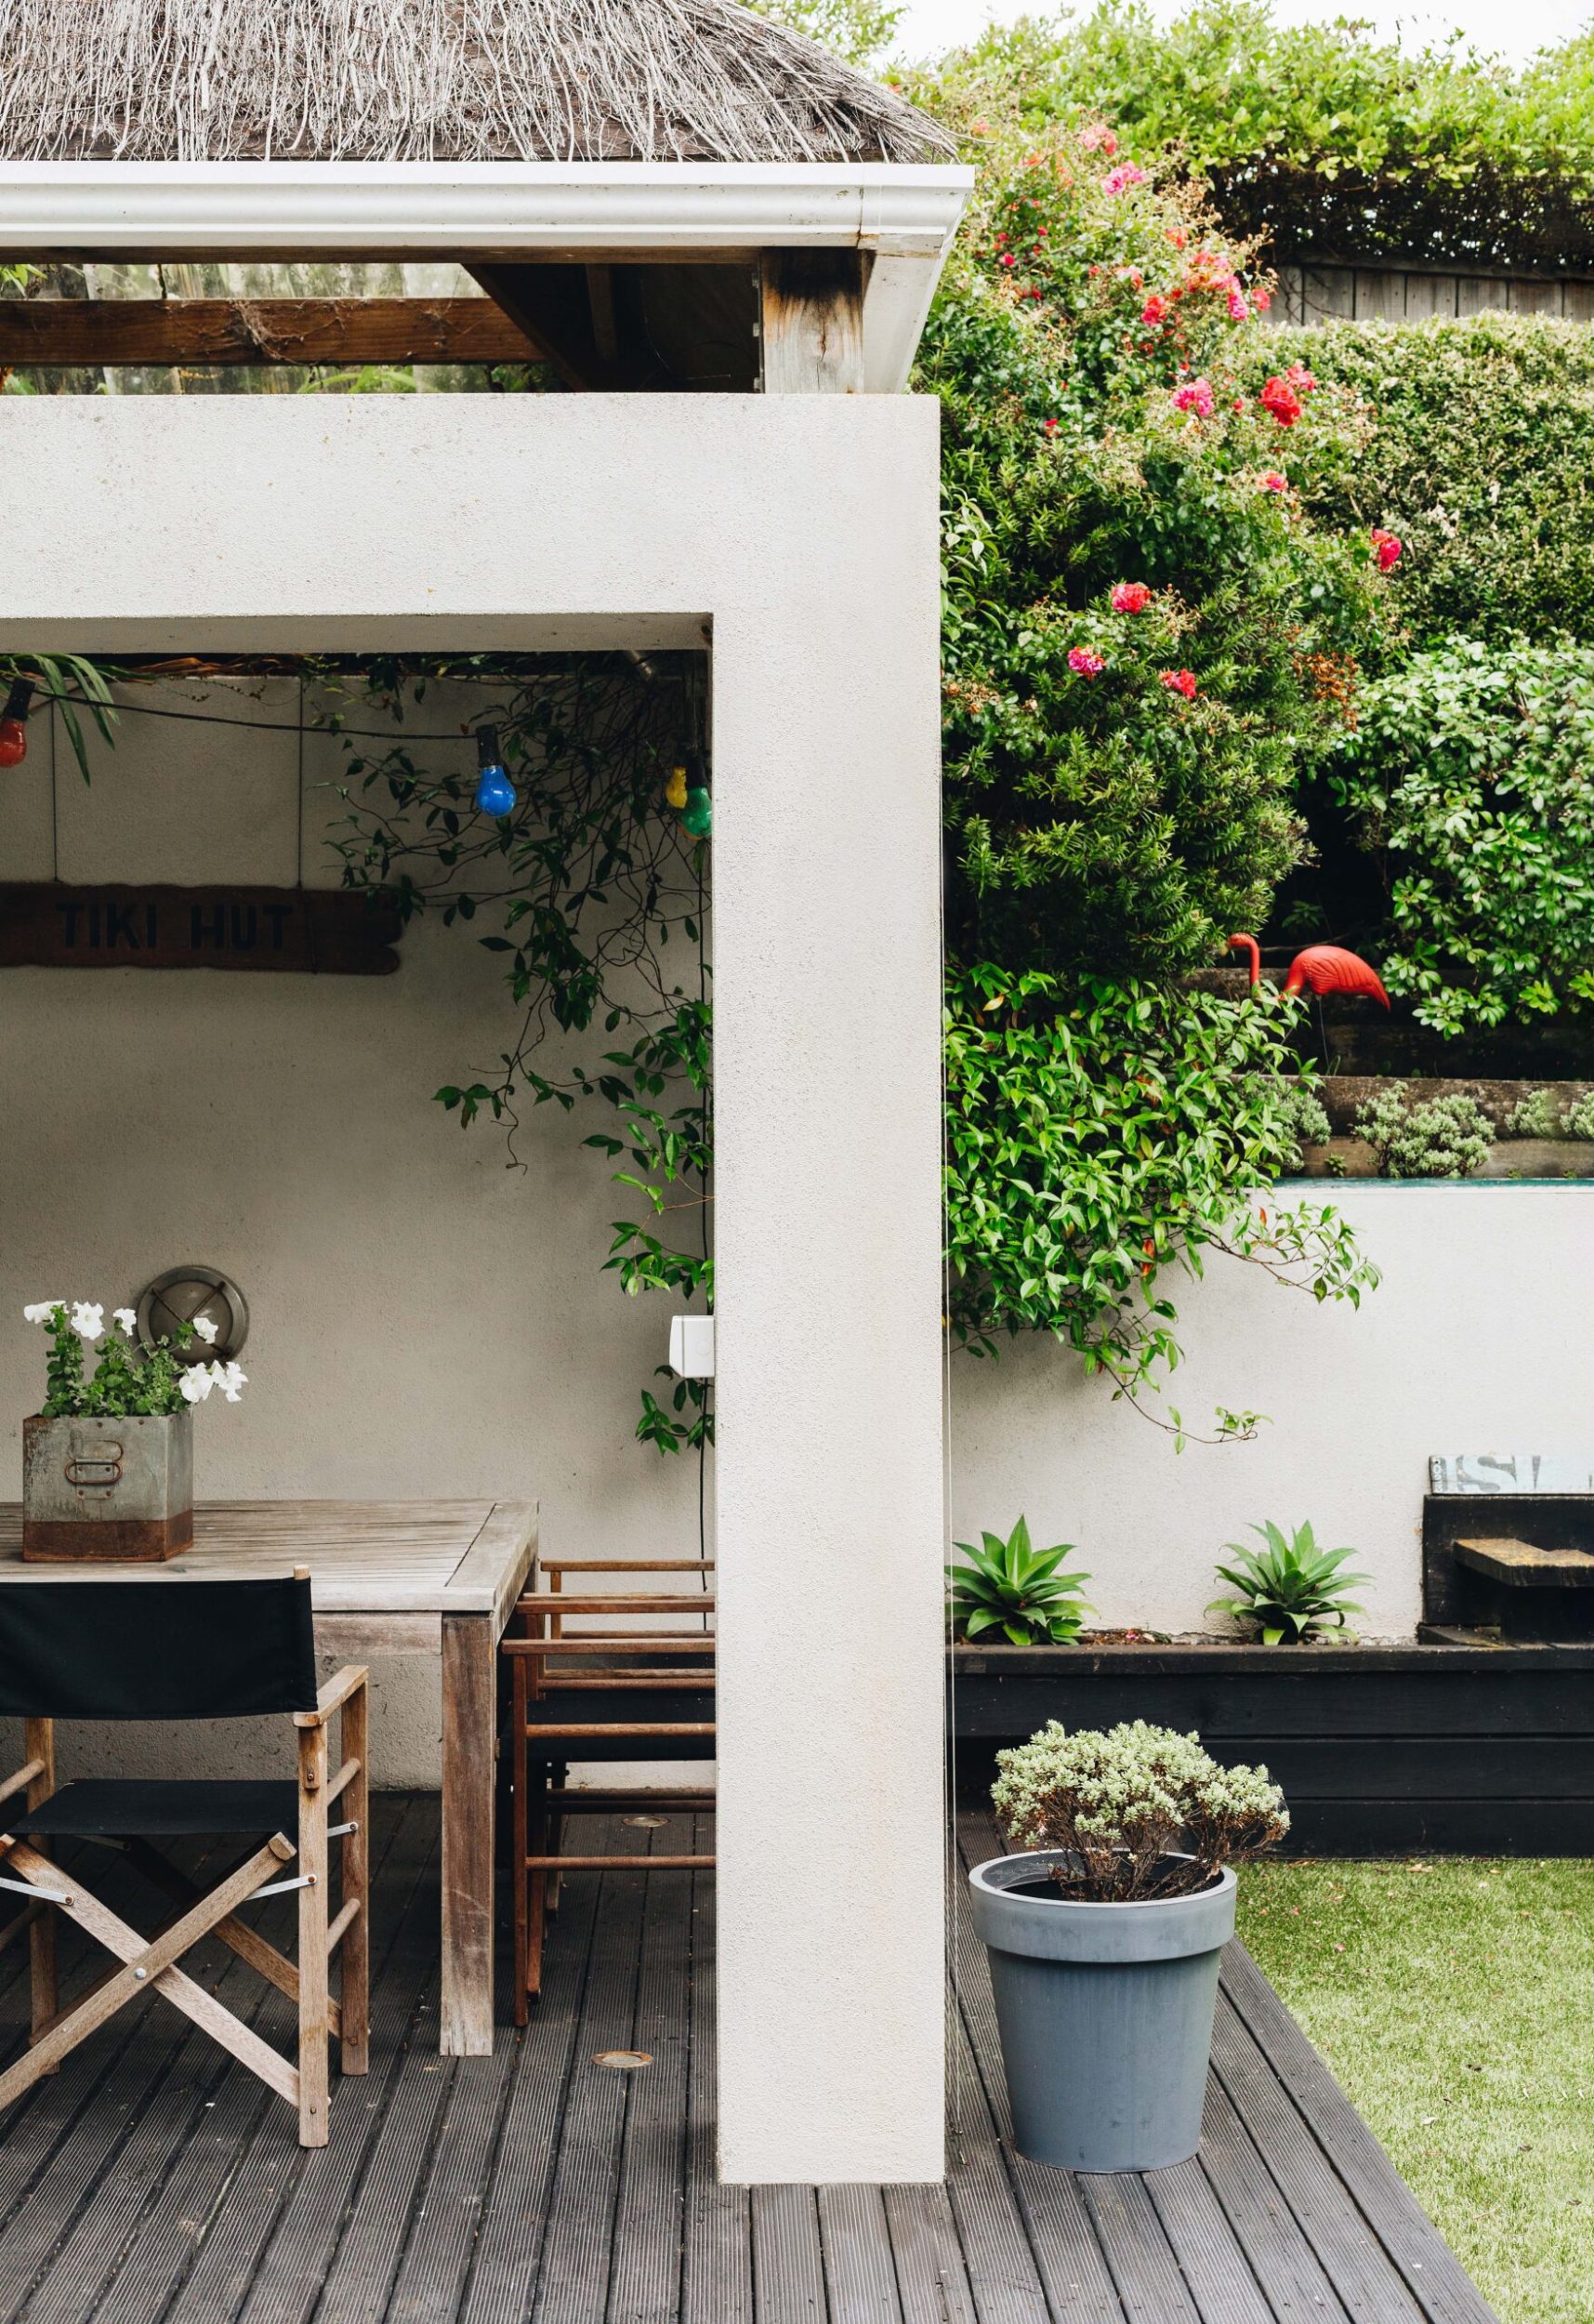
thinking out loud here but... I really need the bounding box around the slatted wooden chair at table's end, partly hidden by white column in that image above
[502,1557,718,2027]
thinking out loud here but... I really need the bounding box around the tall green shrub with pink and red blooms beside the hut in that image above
[918,84,1376,976]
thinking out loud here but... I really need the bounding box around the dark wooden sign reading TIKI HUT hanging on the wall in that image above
[0,881,402,976]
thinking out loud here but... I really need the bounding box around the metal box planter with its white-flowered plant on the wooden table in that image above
[23,1300,244,1565]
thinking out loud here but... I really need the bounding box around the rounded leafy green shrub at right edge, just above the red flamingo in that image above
[1332,640,1594,1035]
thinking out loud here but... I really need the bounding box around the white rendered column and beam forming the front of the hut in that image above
[0,395,943,2180]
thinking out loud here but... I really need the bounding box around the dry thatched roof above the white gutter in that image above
[0,0,951,163]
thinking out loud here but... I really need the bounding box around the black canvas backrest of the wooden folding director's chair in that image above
[0,1578,316,1720]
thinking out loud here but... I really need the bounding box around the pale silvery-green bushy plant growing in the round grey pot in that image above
[990,1720,1290,1904]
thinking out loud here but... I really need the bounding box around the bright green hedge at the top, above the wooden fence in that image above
[911,0,1594,272]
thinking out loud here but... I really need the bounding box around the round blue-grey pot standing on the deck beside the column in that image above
[969,1850,1236,2171]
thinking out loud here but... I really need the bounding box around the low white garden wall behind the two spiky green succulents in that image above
[951,1181,1594,1636]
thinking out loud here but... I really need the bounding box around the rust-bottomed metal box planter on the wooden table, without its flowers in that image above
[23,1411,193,1565]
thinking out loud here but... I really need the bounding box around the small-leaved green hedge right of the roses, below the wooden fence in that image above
[1255,316,1594,649]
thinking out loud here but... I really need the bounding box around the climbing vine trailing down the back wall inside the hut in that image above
[321,655,714,1453]
